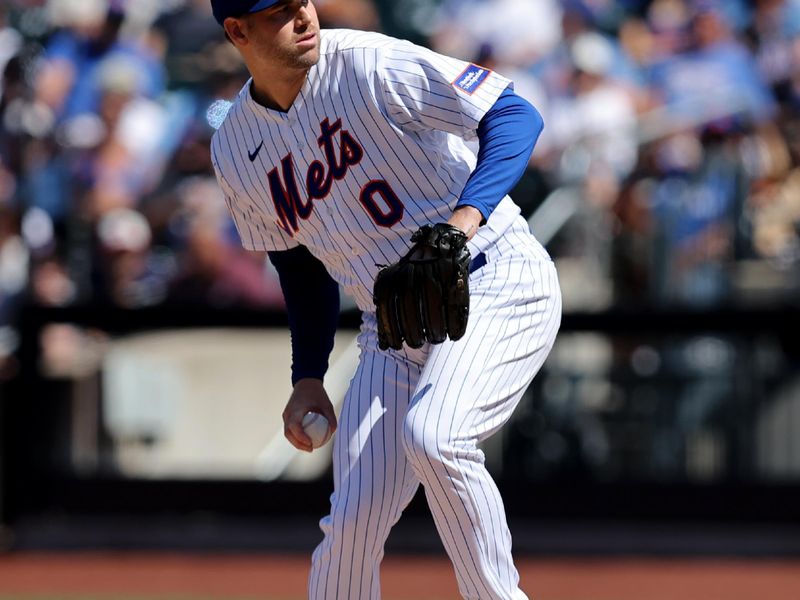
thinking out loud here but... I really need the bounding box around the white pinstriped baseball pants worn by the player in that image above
[309,218,561,600]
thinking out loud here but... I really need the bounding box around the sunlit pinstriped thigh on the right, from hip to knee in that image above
[408,253,561,442]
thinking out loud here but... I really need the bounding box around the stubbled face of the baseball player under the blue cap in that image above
[244,0,320,69]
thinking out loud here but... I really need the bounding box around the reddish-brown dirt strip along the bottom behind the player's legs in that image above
[0,553,800,600]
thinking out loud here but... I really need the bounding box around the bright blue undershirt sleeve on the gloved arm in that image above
[456,87,544,222]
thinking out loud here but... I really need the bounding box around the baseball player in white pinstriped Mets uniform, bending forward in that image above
[211,0,561,600]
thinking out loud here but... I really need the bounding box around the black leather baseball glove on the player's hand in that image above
[373,223,470,350]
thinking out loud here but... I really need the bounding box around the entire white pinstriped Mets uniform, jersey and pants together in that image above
[212,30,561,600]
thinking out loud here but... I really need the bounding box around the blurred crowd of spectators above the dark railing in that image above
[0,0,800,376]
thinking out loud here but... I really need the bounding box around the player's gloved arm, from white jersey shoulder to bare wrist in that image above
[376,42,543,237]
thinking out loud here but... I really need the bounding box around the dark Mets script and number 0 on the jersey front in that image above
[267,119,404,237]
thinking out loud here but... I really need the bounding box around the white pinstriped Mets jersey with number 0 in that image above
[211,30,519,312]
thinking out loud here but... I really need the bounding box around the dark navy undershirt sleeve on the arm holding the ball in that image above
[268,246,339,385]
